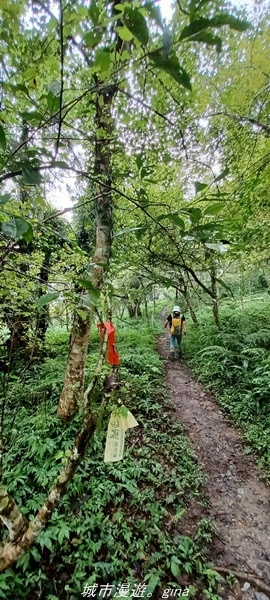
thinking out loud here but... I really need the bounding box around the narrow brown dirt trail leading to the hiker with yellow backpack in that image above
[158,334,270,600]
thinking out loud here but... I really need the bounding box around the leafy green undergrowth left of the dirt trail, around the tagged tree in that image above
[0,323,223,600]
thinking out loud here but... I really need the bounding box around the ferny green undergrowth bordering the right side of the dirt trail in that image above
[186,298,270,478]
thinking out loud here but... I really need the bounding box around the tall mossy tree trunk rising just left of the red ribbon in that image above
[57,86,117,419]
